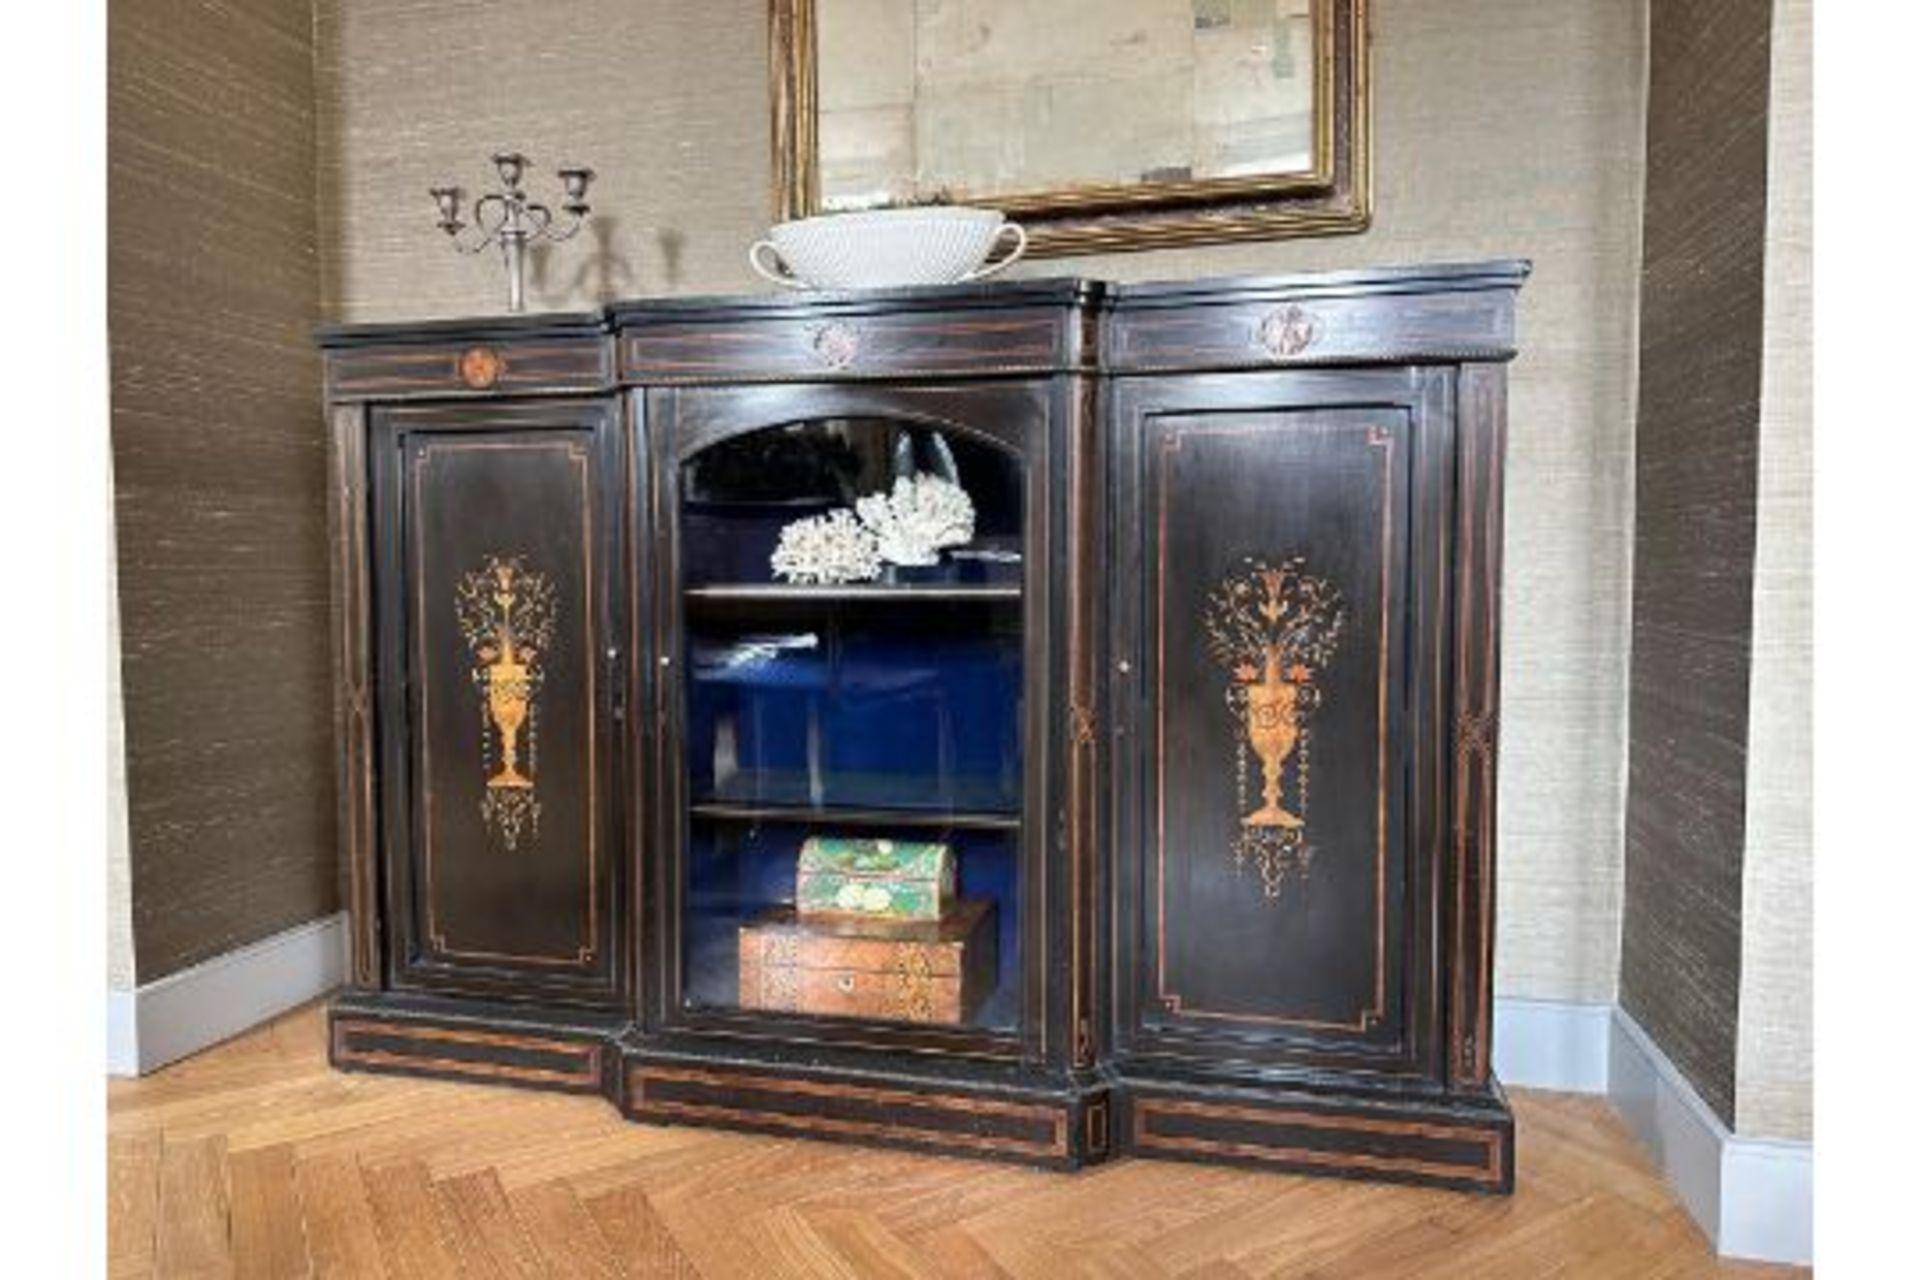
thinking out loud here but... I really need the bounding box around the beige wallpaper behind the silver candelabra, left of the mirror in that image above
[315,0,772,320]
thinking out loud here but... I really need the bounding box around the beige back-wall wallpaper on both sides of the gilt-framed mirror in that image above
[317,0,1644,1002]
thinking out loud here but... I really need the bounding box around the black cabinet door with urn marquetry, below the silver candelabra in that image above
[372,401,624,1004]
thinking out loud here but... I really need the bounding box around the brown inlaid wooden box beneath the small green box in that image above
[739,898,995,1025]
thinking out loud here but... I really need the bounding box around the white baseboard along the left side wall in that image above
[108,912,348,1075]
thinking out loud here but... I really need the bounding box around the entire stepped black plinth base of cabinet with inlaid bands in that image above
[328,992,1513,1196]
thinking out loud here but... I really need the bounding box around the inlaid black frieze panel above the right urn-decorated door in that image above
[1106,273,1513,372]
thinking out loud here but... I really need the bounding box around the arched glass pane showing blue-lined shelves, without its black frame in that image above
[668,416,1027,1032]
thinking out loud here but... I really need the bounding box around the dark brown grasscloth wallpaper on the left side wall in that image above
[108,0,336,983]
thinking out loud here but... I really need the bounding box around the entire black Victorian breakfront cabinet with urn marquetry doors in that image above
[321,263,1524,1192]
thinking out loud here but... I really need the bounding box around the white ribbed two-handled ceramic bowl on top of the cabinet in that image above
[747,205,1027,290]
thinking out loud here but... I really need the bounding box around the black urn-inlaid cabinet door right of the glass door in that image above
[1110,370,1453,1079]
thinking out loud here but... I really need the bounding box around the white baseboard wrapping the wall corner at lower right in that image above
[1605,1009,1812,1265]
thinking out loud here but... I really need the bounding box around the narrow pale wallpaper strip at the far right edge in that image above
[1734,0,1814,1138]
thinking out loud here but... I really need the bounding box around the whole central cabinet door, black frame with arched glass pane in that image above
[645,382,1064,1061]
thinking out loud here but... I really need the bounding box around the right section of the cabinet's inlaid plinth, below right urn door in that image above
[1114,1080,1513,1196]
